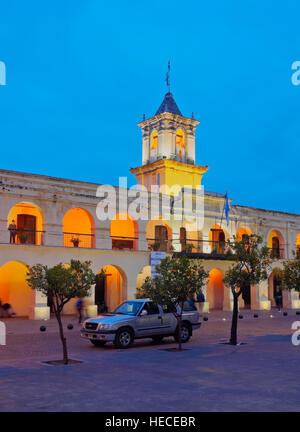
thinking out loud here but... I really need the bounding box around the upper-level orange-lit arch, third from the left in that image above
[110,213,139,250]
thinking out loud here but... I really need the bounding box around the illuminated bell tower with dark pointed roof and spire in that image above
[130,72,208,193]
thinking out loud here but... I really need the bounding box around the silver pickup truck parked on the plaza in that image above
[80,299,201,348]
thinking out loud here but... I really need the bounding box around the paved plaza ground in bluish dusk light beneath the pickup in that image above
[0,311,300,412]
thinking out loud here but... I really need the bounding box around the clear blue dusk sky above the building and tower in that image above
[0,0,300,214]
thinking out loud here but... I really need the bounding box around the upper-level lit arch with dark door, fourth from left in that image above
[146,217,172,252]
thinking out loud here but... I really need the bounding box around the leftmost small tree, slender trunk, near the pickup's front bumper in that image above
[26,260,99,364]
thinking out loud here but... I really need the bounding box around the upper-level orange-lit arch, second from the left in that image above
[63,207,95,248]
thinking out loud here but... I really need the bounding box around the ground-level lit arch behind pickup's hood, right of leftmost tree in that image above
[95,265,127,312]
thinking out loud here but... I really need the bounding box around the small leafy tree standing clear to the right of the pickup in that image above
[224,234,271,345]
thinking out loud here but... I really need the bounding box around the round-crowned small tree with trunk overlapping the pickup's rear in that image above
[137,255,208,351]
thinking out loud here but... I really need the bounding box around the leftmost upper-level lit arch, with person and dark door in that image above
[7,202,45,245]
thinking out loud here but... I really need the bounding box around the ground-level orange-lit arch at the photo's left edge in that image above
[0,261,34,317]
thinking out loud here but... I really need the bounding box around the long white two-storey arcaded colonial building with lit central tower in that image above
[0,92,300,319]
